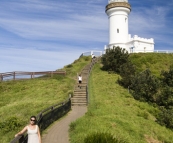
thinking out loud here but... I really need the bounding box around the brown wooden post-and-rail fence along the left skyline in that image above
[0,70,66,81]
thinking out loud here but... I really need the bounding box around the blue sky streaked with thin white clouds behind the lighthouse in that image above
[0,0,173,73]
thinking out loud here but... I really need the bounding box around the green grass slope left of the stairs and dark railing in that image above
[0,57,91,143]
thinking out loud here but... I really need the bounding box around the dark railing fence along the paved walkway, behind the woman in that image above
[10,98,71,143]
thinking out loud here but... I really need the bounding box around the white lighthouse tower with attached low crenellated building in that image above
[105,0,154,53]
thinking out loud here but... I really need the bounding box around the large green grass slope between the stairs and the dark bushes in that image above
[70,59,173,143]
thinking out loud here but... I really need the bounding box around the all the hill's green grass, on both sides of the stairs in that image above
[0,53,173,143]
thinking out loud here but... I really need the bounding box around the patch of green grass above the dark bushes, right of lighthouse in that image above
[130,53,173,77]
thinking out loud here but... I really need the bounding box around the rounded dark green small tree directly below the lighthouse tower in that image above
[101,46,129,73]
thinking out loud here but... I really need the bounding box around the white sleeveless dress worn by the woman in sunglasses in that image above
[27,125,39,143]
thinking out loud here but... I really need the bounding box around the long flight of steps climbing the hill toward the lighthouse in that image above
[71,62,95,106]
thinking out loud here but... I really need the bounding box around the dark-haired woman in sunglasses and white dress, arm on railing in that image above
[15,116,41,143]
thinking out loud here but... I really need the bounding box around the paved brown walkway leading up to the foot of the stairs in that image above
[42,106,87,143]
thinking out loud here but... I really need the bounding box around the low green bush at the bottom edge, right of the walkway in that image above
[84,133,125,143]
